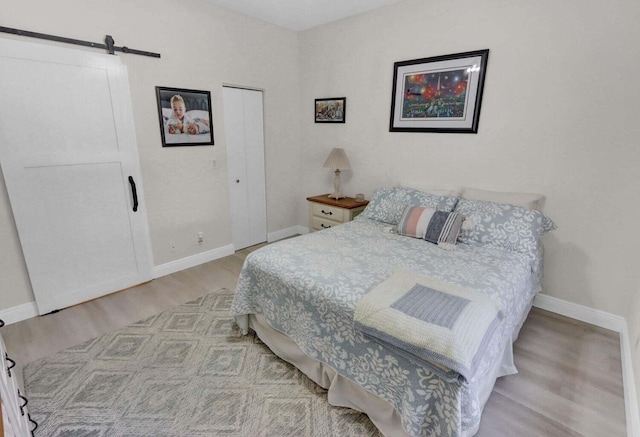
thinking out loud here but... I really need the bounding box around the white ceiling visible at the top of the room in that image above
[209,0,400,31]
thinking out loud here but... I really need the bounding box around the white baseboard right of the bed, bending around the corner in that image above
[533,293,640,437]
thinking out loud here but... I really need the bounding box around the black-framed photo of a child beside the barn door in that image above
[156,86,213,147]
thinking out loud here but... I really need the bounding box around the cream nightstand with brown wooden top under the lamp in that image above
[307,194,369,232]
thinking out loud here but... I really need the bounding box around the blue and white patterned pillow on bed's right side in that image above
[454,198,556,254]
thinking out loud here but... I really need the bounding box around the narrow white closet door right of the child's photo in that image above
[222,87,267,250]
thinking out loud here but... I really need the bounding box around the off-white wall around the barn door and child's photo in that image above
[0,0,300,310]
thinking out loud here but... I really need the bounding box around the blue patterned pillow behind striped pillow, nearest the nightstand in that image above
[361,187,458,225]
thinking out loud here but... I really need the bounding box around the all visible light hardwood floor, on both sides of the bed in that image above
[1,247,626,437]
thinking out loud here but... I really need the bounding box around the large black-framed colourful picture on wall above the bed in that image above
[389,49,489,134]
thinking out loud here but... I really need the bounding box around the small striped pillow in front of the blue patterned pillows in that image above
[398,206,464,250]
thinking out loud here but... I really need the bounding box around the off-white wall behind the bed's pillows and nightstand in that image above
[299,0,640,410]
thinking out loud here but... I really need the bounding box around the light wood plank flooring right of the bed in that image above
[478,308,627,437]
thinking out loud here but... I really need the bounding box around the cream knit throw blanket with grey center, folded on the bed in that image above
[354,270,502,380]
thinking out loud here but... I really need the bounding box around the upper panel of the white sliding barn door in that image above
[0,58,119,155]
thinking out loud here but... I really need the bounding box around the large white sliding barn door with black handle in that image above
[0,40,151,314]
